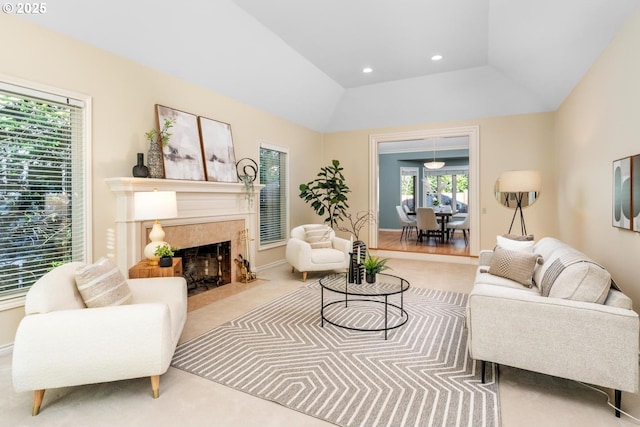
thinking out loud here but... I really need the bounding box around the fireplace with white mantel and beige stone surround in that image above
[105,178,262,282]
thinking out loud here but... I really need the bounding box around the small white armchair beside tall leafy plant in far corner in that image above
[286,224,352,281]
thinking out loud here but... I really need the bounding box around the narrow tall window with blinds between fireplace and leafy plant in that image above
[260,144,289,248]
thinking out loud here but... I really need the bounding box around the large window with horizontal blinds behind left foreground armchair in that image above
[0,82,86,301]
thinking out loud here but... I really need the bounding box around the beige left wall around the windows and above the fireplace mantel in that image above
[0,14,322,347]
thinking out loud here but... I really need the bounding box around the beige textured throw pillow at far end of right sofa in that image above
[489,246,541,288]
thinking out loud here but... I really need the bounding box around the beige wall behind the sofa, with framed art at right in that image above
[554,10,640,310]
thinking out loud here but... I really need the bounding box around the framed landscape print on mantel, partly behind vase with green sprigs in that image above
[156,105,205,181]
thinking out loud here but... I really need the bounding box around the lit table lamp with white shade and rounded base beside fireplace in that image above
[133,190,178,265]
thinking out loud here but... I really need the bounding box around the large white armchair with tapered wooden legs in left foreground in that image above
[12,262,187,415]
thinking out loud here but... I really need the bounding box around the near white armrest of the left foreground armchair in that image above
[12,303,175,391]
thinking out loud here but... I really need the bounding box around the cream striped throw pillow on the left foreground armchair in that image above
[76,258,131,308]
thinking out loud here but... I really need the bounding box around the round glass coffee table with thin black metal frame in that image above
[320,273,409,340]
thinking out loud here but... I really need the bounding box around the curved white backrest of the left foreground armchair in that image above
[24,262,86,314]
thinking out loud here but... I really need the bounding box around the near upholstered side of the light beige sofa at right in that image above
[467,284,640,392]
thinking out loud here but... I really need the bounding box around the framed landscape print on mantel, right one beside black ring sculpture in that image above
[198,117,238,182]
